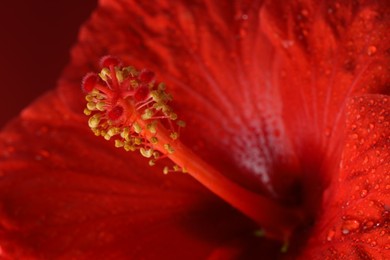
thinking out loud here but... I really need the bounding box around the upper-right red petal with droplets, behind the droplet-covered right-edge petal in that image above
[261,0,390,185]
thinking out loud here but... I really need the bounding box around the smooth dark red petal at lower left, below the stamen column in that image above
[0,93,278,259]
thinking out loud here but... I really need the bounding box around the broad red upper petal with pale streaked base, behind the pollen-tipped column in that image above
[55,0,294,195]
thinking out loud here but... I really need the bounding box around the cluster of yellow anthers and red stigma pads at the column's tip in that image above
[82,56,185,173]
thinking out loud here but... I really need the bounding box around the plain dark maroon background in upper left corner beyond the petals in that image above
[0,0,97,127]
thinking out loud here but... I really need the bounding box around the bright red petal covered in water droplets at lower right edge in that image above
[303,95,390,259]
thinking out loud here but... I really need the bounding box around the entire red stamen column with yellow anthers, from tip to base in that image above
[82,56,302,242]
